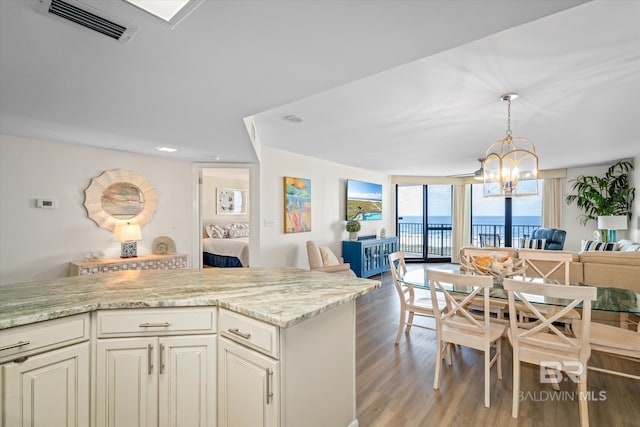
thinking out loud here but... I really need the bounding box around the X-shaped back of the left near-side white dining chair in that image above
[427,268,493,338]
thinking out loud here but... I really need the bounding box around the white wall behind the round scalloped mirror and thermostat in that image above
[0,135,194,283]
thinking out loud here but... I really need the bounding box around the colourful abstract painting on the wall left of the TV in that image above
[284,176,311,233]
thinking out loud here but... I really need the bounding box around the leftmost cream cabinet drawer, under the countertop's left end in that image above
[0,313,89,363]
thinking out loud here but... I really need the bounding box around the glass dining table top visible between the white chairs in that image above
[399,267,640,313]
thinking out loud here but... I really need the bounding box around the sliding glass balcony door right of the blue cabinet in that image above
[396,185,453,262]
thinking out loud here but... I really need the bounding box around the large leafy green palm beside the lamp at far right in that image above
[566,160,636,241]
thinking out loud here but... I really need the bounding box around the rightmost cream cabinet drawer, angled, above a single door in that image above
[218,310,279,359]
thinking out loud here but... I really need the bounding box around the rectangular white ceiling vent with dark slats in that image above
[38,0,137,43]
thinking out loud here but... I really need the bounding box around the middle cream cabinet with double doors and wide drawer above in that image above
[95,308,216,427]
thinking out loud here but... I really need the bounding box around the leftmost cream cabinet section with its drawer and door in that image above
[0,315,89,427]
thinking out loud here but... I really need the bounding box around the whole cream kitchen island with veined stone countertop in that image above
[0,268,380,426]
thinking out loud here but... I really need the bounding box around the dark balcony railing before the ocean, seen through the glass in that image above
[398,222,540,258]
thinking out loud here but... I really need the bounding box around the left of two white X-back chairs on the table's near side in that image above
[427,269,506,408]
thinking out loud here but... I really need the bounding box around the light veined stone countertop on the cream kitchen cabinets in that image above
[0,268,380,329]
